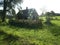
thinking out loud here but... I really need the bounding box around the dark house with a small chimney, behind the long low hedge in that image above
[16,8,38,20]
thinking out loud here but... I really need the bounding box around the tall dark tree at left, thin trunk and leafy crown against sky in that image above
[2,0,22,22]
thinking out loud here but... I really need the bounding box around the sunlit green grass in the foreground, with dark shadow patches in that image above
[0,16,60,45]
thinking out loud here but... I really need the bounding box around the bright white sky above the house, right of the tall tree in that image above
[22,0,60,14]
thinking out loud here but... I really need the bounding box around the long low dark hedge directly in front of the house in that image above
[9,20,42,28]
